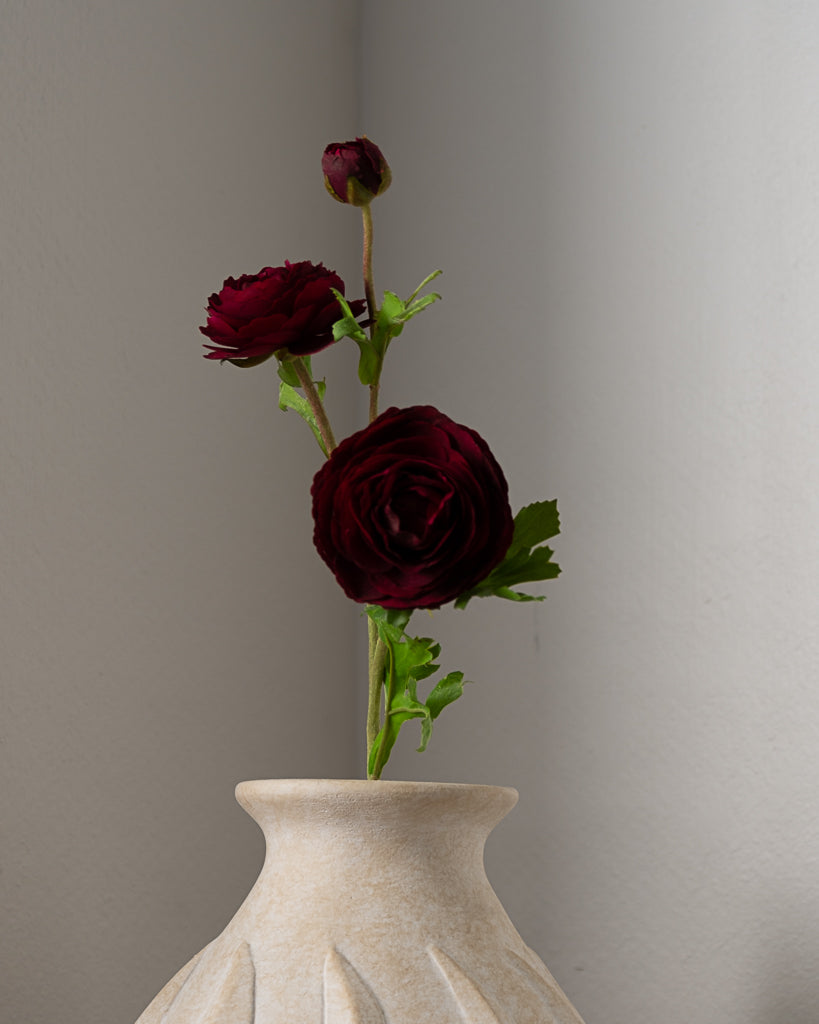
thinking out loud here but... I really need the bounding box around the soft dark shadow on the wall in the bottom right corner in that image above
[750,892,819,1024]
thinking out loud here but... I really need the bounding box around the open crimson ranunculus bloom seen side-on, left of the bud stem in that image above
[200,260,364,366]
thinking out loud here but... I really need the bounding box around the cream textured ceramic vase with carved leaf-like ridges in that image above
[137,779,583,1024]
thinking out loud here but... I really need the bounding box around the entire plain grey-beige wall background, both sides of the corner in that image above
[0,0,819,1024]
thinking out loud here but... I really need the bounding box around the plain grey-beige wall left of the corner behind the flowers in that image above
[0,0,357,1024]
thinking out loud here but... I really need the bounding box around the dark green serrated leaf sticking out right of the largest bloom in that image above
[455,501,560,608]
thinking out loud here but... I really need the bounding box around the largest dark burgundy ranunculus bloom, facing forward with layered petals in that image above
[311,406,513,608]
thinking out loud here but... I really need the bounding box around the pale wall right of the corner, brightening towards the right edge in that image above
[363,0,819,1024]
